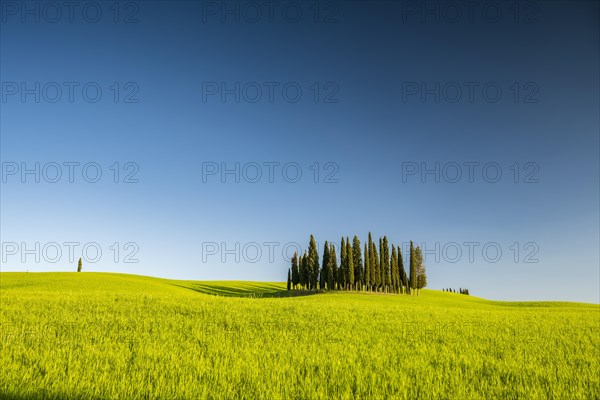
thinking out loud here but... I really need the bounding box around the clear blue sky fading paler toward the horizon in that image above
[0,0,600,302]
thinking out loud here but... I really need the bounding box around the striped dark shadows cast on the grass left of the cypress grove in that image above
[172,283,320,298]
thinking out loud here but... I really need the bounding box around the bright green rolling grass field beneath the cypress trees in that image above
[0,273,600,400]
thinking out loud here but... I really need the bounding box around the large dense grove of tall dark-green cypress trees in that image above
[287,232,427,295]
